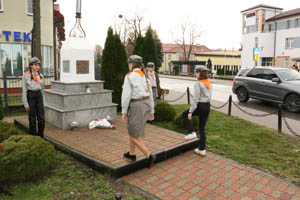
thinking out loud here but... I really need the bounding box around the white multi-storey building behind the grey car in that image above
[241,4,300,67]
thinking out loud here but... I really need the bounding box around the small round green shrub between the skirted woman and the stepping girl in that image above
[154,101,176,121]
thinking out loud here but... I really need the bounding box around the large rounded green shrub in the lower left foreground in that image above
[0,135,55,183]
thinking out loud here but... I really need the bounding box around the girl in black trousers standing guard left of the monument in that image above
[23,57,45,138]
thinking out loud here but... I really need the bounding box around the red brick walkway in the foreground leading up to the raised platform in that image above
[121,151,300,200]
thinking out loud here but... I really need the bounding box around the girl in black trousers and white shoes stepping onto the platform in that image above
[182,66,212,156]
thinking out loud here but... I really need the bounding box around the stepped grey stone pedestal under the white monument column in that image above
[44,81,117,129]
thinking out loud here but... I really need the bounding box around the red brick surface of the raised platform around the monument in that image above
[11,116,190,167]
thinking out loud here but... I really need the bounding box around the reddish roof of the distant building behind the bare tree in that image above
[162,44,210,54]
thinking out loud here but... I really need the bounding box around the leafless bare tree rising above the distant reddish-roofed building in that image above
[172,19,203,60]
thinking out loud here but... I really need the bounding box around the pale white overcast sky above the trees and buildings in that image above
[57,0,300,49]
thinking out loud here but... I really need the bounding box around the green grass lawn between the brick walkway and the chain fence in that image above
[155,105,300,185]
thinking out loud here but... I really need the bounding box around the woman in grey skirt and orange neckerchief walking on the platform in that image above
[122,55,156,167]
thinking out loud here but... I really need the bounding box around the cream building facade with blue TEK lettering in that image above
[0,0,54,78]
